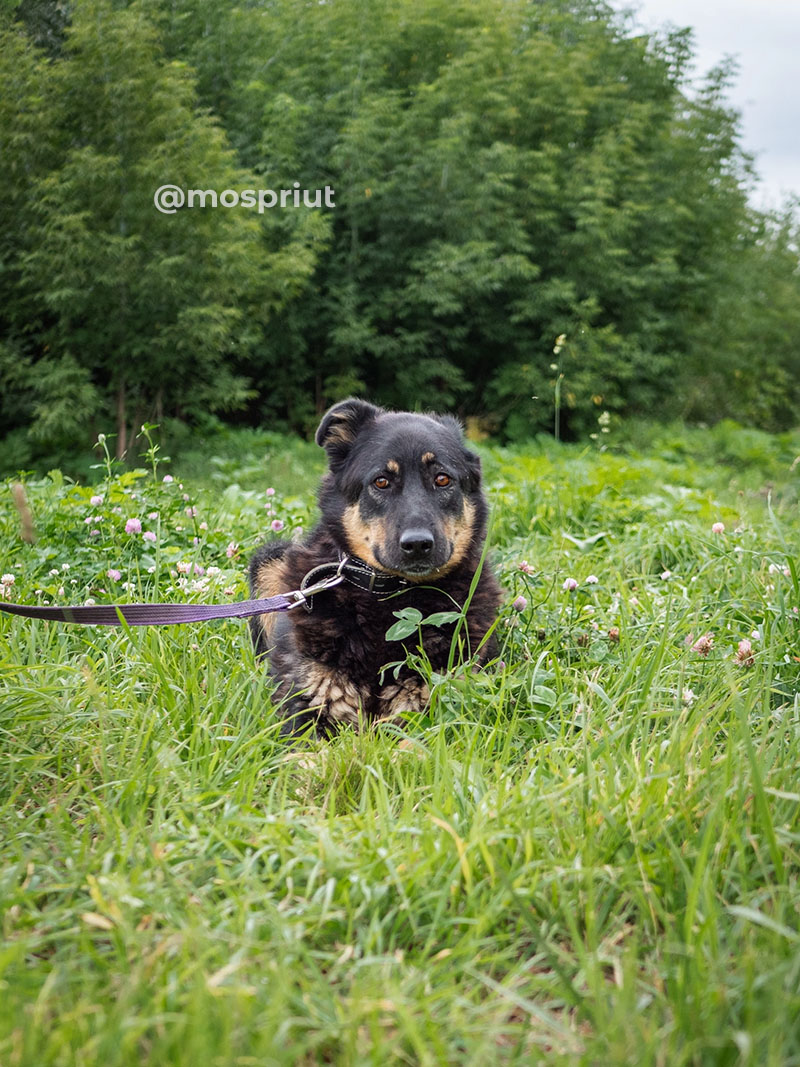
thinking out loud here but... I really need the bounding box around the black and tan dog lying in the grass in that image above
[250,399,499,736]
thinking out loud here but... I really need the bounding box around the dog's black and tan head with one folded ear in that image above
[317,399,486,582]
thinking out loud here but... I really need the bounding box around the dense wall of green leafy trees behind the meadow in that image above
[0,0,800,471]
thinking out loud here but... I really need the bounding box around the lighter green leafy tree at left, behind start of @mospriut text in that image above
[3,0,321,455]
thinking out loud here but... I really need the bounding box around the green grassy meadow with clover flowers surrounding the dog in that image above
[0,431,800,1067]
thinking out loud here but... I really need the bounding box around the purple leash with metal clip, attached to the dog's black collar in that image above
[0,556,409,626]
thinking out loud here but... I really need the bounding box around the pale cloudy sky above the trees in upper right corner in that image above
[610,0,800,210]
